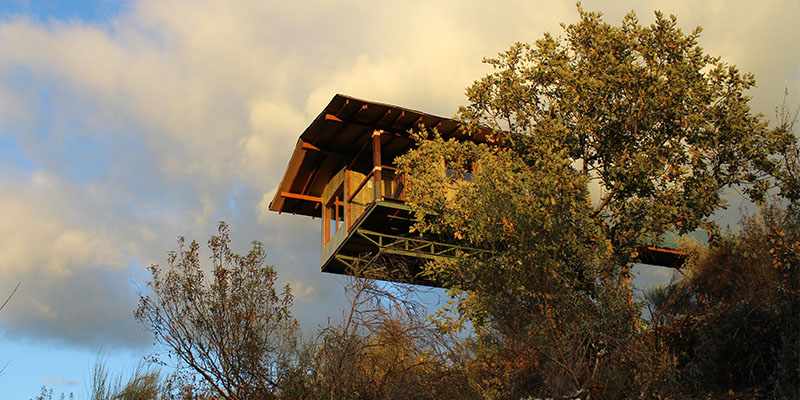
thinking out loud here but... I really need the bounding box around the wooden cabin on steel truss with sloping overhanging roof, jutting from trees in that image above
[269,95,684,284]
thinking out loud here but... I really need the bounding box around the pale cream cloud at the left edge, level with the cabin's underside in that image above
[0,172,130,281]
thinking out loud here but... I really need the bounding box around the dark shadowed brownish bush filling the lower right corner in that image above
[648,205,800,398]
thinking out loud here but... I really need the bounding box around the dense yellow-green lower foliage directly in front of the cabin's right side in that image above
[398,132,635,398]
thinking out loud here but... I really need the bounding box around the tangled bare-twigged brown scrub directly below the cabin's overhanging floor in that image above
[306,261,478,399]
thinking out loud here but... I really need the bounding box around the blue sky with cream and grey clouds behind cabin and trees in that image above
[0,0,800,399]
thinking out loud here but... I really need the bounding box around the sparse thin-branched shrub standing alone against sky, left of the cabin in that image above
[135,223,302,399]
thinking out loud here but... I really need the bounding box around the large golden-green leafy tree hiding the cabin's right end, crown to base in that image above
[397,6,797,398]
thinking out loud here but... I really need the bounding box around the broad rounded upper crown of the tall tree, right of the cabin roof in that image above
[459,8,796,253]
